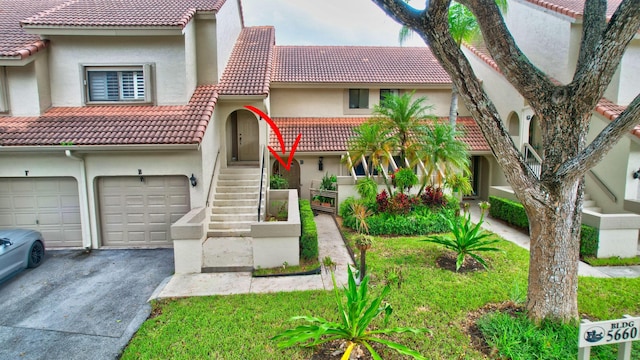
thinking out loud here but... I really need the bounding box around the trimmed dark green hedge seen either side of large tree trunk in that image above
[489,196,599,257]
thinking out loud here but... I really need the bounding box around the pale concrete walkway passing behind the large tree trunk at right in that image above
[469,201,640,278]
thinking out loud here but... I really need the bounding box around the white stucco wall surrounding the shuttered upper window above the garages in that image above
[49,36,192,106]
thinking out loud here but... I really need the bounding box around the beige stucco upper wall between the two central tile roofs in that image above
[270,85,458,117]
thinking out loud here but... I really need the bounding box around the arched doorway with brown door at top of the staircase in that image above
[227,110,260,164]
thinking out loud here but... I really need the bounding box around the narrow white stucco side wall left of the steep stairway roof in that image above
[215,0,242,83]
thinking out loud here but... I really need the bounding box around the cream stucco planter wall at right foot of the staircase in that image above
[251,190,301,268]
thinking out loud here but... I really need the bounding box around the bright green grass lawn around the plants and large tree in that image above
[122,233,640,359]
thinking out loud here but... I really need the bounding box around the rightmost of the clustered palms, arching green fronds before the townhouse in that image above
[420,121,470,192]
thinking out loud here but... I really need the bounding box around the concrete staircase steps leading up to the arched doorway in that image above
[207,166,267,237]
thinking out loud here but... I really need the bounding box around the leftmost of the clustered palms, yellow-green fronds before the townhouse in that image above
[347,121,396,177]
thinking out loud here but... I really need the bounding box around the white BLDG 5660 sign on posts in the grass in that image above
[578,315,640,360]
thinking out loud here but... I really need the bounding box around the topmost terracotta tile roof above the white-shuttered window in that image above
[22,0,225,28]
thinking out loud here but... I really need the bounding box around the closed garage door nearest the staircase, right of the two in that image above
[98,176,191,247]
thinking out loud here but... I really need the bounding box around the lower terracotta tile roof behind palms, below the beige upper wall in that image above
[269,117,490,153]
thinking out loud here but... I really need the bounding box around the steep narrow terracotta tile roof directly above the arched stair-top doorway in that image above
[218,26,276,95]
